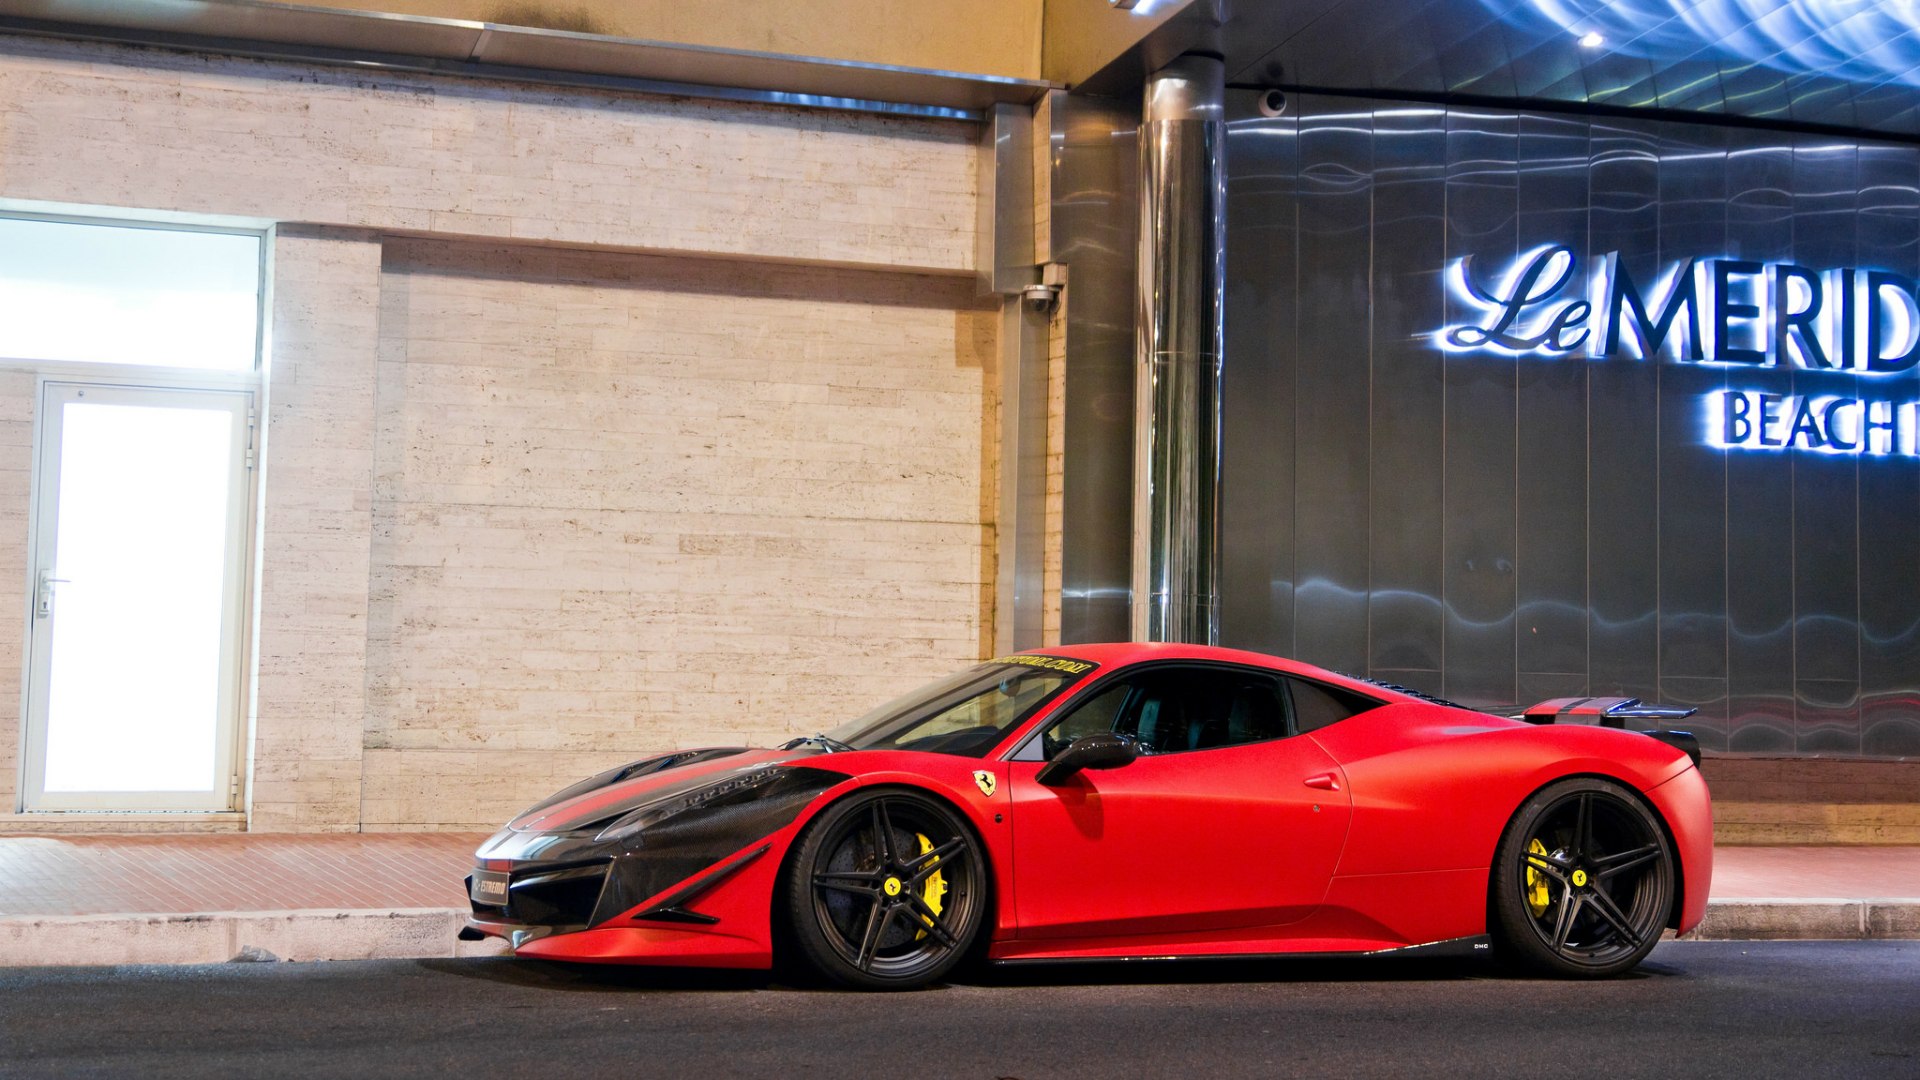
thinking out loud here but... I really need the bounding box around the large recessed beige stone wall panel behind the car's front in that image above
[363,242,995,826]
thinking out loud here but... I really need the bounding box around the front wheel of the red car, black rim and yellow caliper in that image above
[787,788,987,990]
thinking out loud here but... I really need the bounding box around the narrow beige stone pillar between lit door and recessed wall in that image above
[248,227,382,830]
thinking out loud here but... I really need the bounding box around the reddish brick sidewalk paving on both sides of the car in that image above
[0,832,1920,915]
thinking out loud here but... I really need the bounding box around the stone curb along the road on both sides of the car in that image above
[0,897,1920,967]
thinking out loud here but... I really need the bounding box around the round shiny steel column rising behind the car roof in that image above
[1133,56,1227,644]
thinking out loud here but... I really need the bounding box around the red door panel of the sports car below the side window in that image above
[1010,738,1350,938]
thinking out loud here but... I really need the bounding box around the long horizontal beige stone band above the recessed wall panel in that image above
[0,37,975,273]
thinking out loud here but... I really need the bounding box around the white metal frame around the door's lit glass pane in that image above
[12,374,263,803]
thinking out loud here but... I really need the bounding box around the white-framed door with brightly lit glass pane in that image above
[21,382,253,811]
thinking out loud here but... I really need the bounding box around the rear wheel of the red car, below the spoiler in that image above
[1490,778,1674,978]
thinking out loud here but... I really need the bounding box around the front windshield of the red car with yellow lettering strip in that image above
[826,655,1094,757]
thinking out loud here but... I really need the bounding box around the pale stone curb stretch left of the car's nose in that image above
[0,907,507,967]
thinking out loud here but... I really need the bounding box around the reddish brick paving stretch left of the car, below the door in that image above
[0,832,486,915]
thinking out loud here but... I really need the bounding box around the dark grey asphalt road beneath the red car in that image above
[0,942,1920,1080]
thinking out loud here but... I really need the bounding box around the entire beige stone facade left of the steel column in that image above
[0,38,996,830]
